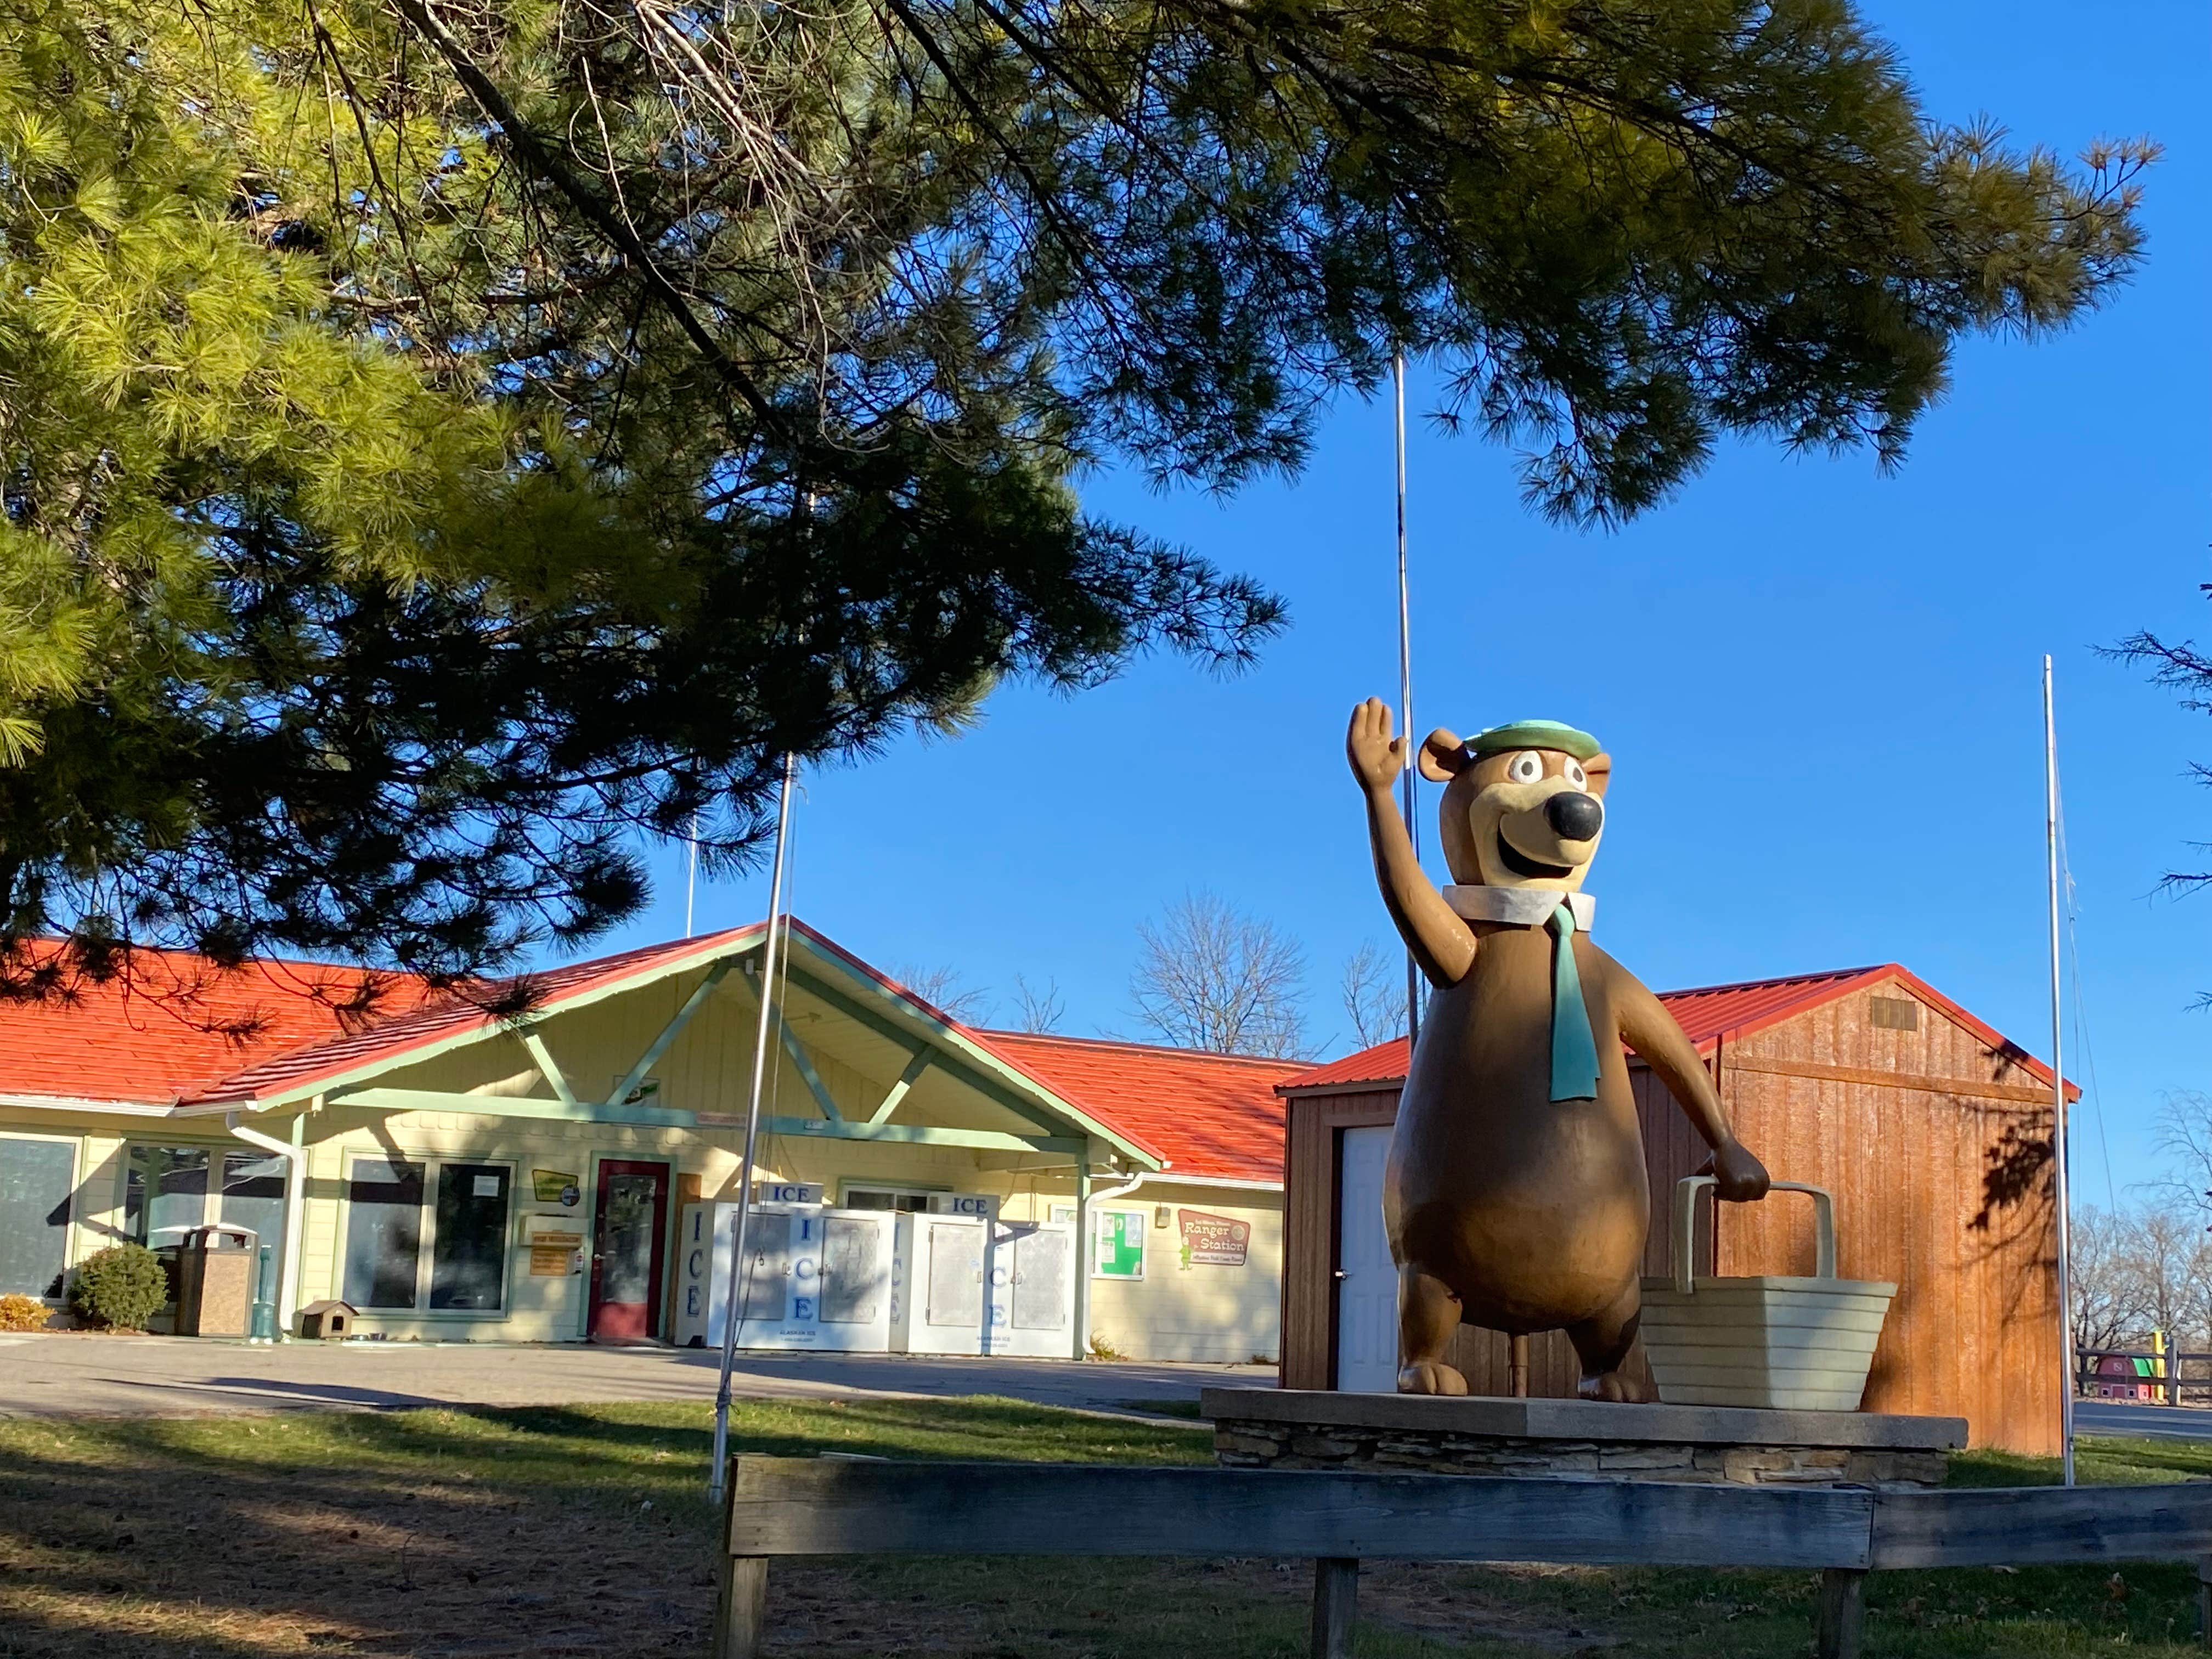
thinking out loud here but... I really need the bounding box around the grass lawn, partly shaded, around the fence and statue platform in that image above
[0,1398,2212,1659]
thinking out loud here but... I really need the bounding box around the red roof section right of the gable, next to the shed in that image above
[971,1031,1305,1183]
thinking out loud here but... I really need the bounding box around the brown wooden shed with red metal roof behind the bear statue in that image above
[1278,962,2077,1453]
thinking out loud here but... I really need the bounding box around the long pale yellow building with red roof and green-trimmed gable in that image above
[0,922,1299,1361]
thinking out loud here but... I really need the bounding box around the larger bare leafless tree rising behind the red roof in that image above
[1128,891,1305,1057]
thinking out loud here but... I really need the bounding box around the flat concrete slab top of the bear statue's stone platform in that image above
[1199,1389,1966,1451]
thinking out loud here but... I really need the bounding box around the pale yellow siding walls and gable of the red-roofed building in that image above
[0,969,1283,1361]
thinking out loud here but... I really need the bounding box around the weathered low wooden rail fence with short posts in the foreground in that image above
[714,1458,2212,1659]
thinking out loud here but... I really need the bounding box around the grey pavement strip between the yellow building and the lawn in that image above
[0,1334,1274,1418]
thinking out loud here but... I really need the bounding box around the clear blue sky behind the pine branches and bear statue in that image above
[575,0,2212,1203]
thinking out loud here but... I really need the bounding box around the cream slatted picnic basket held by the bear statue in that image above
[1644,1175,1898,1411]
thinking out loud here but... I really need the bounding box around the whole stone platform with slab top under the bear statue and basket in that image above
[1199,1389,1966,1489]
